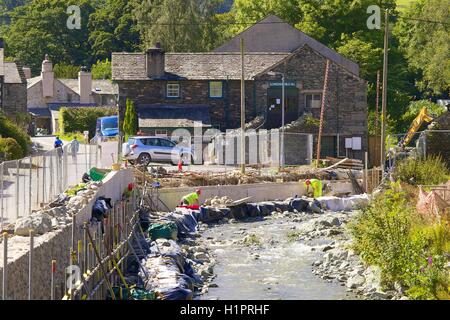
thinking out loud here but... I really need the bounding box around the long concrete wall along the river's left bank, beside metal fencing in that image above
[0,170,133,300]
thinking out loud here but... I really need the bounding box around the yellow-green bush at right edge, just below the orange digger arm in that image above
[394,156,450,185]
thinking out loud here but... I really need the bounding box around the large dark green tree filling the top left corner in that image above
[2,0,94,74]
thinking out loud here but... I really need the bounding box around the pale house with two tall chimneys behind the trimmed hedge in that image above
[27,56,118,134]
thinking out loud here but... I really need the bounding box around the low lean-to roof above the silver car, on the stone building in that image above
[137,104,211,128]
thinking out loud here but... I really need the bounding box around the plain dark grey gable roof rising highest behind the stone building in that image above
[213,15,359,76]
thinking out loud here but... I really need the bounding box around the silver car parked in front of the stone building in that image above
[122,136,193,166]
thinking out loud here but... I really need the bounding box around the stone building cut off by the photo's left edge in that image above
[0,39,27,118]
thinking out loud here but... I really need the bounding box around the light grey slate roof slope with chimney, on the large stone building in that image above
[112,52,289,80]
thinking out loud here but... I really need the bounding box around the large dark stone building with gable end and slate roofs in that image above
[112,16,367,159]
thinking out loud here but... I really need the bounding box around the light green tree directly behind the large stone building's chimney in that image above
[134,0,221,52]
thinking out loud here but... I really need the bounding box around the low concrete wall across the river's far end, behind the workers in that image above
[154,181,352,211]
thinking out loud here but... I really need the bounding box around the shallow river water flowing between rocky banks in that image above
[200,217,355,300]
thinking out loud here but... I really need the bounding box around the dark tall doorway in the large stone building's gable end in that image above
[267,87,299,129]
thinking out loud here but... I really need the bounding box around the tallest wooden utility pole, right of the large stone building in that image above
[381,9,389,171]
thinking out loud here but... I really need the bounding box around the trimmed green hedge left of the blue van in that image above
[59,107,117,137]
